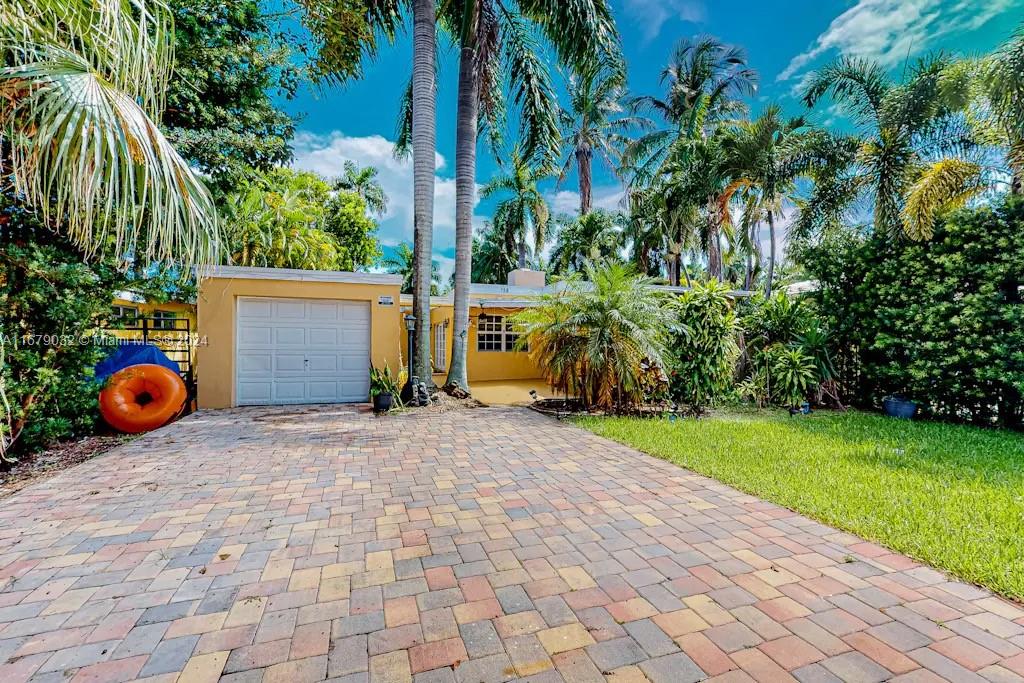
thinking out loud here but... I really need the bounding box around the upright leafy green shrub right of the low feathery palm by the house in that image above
[669,280,738,412]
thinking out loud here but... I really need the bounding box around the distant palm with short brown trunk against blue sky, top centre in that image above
[559,57,642,216]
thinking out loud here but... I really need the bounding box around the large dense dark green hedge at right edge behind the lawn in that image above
[798,198,1024,427]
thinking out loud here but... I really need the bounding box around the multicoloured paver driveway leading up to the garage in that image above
[0,407,1024,683]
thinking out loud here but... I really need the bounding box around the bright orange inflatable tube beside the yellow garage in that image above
[99,364,187,434]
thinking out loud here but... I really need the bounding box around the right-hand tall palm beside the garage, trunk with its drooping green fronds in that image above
[442,0,617,391]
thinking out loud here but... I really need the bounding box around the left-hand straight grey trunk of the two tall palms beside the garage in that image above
[413,0,437,386]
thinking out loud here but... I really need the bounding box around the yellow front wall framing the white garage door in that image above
[197,278,404,409]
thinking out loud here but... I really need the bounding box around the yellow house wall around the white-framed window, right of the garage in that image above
[399,296,544,387]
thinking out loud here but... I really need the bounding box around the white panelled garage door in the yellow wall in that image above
[234,297,370,405]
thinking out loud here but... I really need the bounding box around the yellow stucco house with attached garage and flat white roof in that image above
[197,266,548,409]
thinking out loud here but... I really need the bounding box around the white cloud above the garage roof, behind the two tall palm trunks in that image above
[292,131,471,253]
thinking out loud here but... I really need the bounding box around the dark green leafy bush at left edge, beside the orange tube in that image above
[0,206,125,454]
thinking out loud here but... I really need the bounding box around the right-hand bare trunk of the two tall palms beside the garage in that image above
[441,0,480,391]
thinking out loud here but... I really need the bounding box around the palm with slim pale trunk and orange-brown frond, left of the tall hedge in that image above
[722,104,816,297]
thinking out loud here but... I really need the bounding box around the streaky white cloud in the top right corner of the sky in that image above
[777,0,1020,81]
